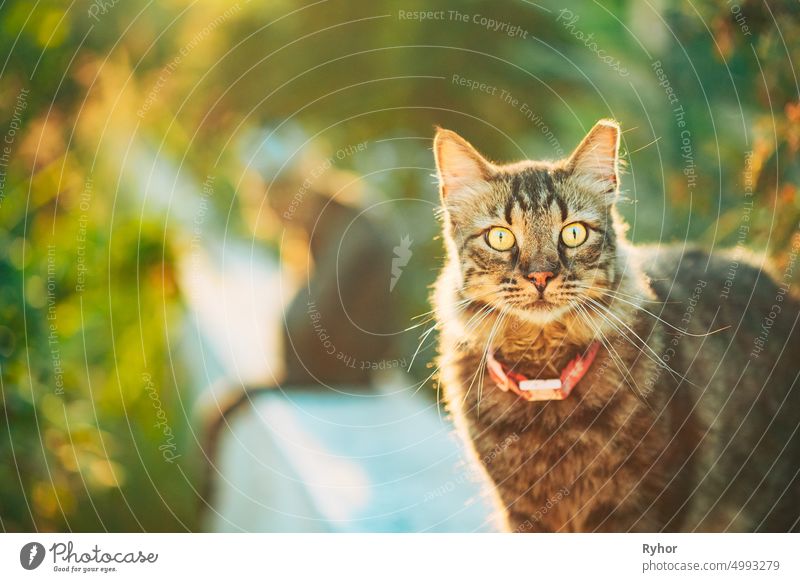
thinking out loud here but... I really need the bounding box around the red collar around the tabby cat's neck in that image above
[486,342,600,401]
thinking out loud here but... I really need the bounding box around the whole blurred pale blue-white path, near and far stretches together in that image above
[131,143,492,532]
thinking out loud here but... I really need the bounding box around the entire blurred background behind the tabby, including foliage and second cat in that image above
[0,0,800,531]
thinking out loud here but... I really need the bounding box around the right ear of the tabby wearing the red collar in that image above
[567,119,620,203]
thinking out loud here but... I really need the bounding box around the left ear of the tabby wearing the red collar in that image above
[433,127,494,205]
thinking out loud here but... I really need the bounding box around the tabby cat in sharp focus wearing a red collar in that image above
[432,120,800,532]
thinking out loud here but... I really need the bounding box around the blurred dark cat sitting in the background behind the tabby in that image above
[196,186,394,519]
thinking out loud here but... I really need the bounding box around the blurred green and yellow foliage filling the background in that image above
[0,0,800,531]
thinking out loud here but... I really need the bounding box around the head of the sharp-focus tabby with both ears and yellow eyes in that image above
[434,120,620,323]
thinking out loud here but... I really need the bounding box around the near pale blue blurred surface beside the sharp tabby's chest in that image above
[207,388,494,532]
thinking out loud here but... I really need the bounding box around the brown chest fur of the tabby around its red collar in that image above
[434,296,666,531]
